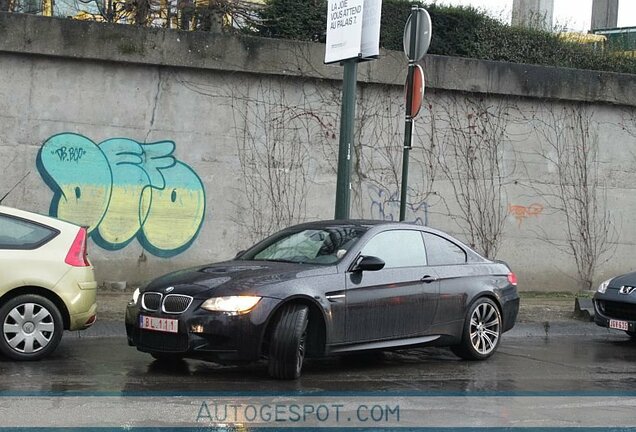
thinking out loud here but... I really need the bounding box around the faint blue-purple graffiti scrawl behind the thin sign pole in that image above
[369,186,428,225]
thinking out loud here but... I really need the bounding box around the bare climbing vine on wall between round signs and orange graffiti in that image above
[424,94,514,258]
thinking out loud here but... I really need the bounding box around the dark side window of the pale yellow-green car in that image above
[0,215,57,249]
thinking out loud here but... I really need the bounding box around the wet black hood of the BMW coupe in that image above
[143,261,335,297]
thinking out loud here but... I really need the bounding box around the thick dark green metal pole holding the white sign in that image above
[335,59,358,219]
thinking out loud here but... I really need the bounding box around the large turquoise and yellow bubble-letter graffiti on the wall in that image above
[37,133,205,257]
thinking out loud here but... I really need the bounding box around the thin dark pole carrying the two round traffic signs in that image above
[400,6,418,221]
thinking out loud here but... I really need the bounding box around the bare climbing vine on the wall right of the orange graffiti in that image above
[530,104,617,290]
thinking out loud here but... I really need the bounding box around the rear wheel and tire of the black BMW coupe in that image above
[451,297,502,360]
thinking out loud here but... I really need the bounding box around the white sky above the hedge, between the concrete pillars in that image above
[434,0,636,32]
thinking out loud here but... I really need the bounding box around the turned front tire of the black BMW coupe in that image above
[268,304,309,380]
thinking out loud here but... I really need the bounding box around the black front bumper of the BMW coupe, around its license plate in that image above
[126,297,280,363]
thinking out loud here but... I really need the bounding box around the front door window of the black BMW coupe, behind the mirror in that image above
[362,230,426,268]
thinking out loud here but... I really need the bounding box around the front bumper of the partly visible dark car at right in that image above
[593,288,636,333]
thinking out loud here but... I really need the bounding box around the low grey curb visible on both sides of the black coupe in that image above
[66,320,623,339]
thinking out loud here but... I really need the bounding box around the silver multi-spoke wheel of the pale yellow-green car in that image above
[2,303,55,354]
